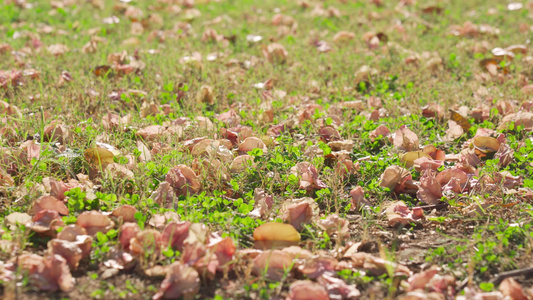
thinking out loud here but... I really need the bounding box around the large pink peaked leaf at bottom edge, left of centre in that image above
[153,261,200,300]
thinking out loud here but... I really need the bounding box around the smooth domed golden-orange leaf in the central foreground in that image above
[254,222,300,249]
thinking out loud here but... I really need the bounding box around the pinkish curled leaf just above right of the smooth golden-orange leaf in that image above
[280,197,318,231]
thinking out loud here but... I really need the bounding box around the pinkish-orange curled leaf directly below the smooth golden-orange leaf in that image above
[252,250,292,281]
